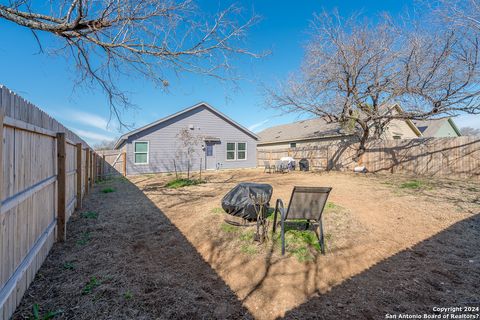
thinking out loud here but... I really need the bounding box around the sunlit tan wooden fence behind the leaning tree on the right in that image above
[257,137,480,179]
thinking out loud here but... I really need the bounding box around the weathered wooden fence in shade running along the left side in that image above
[0,86,113,319]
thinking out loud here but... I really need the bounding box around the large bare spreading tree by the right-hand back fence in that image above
[268,13,480,160]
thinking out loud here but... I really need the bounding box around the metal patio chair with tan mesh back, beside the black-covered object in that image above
[273,187,332,255]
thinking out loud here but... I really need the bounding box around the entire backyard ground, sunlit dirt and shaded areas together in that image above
[14,170,480,319]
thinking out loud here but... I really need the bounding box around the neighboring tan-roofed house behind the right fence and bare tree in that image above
[258,106,422,149]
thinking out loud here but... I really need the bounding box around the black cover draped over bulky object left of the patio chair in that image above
[222,182,273,220]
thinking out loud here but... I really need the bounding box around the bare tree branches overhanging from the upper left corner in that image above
[0,0,259,125]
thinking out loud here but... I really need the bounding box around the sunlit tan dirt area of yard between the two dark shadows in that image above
[129,170,480,319]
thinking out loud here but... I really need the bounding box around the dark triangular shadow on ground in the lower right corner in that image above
[285,212,480,319]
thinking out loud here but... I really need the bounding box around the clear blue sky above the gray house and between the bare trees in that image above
[0,0,480,144]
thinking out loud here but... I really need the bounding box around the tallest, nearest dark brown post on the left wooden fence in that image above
[57,132,67,241]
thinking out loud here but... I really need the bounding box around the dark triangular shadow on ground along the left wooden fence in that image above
[13,177,251,319]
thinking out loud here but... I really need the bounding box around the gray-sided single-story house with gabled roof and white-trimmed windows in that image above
[115,102,258,174]
